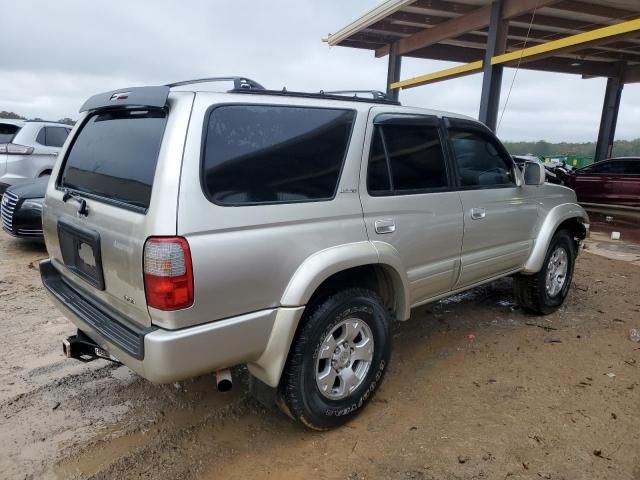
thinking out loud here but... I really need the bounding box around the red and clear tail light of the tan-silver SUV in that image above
[144,237,193,310]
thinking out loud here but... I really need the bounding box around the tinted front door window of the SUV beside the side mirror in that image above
[449,130,515,188]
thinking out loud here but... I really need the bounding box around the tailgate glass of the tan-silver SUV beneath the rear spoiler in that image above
[61,110,166,209]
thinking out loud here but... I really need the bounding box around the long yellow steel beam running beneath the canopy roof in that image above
[390,18,640,89]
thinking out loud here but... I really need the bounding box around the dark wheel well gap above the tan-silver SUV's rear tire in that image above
[306,264,404,320]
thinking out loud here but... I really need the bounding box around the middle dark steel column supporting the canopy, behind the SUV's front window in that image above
[478,0,509,132]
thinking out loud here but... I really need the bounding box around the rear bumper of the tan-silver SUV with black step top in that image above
[40,260,278,383]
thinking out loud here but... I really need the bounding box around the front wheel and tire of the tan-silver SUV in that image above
[513,230,576,315]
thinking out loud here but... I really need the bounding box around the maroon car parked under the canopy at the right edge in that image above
[566,158,640,207]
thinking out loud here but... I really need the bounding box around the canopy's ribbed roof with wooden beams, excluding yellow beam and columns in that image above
[325,0,640,83]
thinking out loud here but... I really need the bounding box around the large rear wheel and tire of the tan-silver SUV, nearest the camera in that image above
[281,288,391,430]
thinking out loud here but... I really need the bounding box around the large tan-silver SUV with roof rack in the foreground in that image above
[40,78,588,429]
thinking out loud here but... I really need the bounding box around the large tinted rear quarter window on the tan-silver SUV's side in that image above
[202,105,355,205]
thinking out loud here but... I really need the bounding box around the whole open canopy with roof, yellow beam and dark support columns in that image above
[323,0,640,161]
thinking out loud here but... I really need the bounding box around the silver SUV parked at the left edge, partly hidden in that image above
[0,118,71,195]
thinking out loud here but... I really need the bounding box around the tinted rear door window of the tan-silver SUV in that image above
[367,125,448,195]
